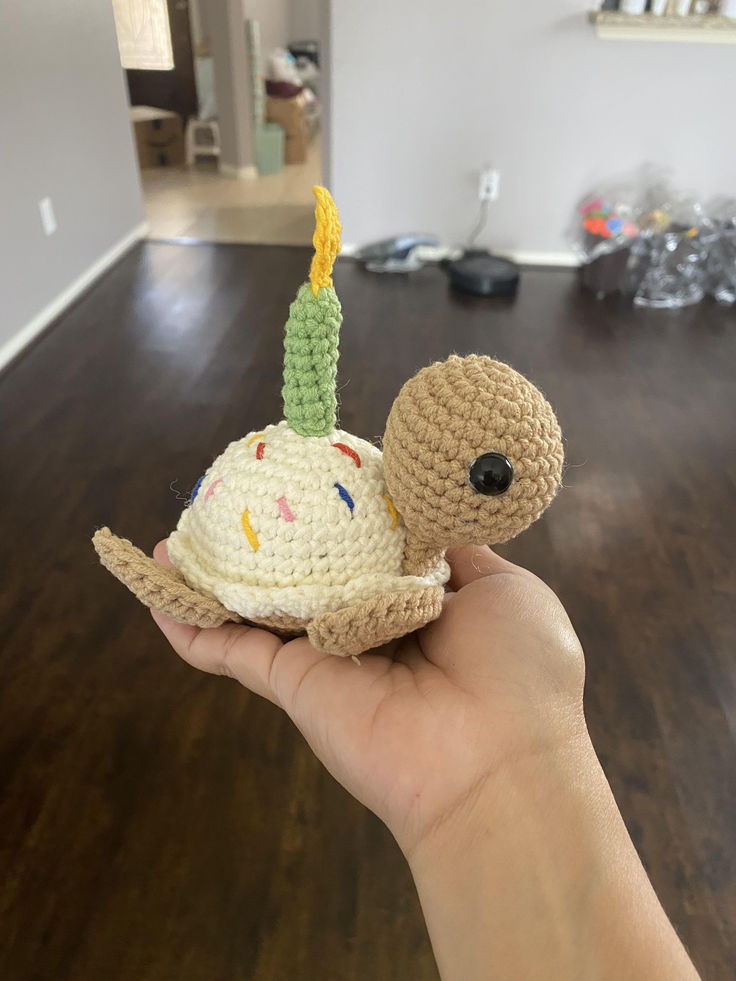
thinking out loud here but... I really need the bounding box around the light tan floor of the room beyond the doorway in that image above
[141,136,322,245]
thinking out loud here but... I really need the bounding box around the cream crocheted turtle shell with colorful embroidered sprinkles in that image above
[168,422,450,620]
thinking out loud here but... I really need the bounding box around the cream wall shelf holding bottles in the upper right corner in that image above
[590,10,736,44]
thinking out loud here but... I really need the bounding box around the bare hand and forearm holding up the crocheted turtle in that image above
[154,542,697,981]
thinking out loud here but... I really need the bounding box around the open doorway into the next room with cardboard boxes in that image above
[114,0,327,245]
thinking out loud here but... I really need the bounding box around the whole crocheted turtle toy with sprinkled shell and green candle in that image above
[93,188,563,655]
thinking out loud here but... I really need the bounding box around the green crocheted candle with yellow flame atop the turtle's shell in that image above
[282,187,342,436]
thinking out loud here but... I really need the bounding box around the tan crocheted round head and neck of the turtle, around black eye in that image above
[383,355,563,556]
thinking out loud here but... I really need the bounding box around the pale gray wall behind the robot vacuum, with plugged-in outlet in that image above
[330,0,736,252]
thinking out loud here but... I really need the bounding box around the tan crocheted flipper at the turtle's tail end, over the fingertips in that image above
[92,528,241,627]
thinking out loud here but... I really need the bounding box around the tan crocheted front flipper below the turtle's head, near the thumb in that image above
[307,586,445,657]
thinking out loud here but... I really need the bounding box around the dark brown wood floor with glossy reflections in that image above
[0,244,736,981]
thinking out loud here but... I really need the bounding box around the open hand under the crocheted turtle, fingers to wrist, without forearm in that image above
[153,542,585,855]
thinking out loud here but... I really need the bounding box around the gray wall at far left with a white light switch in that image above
[0,0,143,345]
